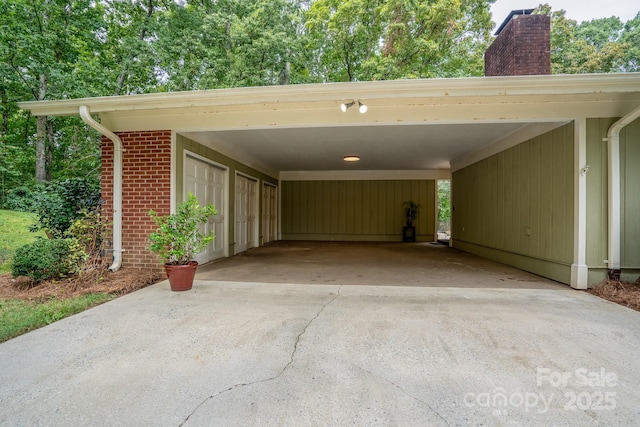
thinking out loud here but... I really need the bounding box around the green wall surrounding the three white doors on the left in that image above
[176,135,278,254]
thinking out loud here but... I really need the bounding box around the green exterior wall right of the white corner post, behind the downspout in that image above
[587,118,640,284]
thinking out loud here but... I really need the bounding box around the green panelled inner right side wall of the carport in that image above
[452,123,574,283]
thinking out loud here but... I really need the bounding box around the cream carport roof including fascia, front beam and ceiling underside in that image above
[19,73,640,176]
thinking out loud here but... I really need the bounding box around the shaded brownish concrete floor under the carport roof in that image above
[198,241,568,289]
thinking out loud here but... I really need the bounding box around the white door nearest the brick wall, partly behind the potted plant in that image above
[184,155,227,264]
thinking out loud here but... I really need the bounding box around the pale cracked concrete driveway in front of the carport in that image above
[0,244,640,426]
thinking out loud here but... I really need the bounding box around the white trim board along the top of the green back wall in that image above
[280,170,451,181]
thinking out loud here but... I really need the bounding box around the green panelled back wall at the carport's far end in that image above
[281,180,436,241]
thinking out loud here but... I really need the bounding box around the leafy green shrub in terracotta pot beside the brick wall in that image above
[149,193,217,291]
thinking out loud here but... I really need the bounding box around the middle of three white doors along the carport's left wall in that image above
[235,175,258,254]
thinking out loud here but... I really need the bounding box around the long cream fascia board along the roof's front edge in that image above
[18,73,640,116]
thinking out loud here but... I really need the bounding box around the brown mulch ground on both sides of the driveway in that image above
[0,269,640,311]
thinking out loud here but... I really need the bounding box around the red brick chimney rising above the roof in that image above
[484,9,551,76]
